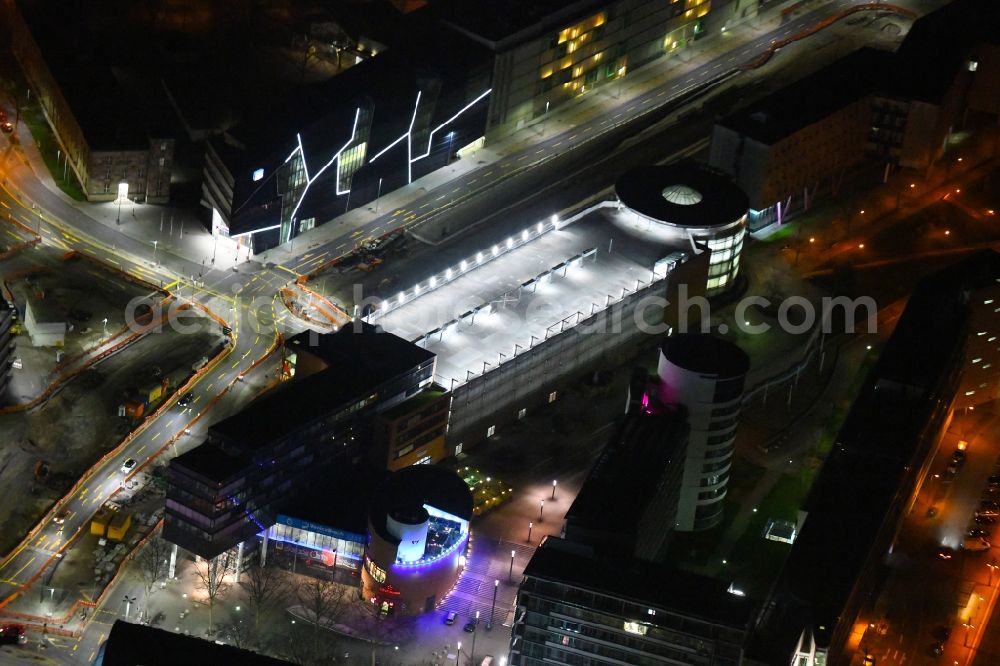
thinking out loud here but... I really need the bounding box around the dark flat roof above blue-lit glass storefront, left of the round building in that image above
[279,465,389,535]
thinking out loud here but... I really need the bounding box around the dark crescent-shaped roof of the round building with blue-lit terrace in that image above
[368,465,472,542]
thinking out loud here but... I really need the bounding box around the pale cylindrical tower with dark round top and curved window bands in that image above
[656,333,750,532]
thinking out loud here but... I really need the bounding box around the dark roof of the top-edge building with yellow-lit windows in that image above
[431,0,605,48]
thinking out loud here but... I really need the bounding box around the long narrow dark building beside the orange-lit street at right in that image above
[746,253,972,666]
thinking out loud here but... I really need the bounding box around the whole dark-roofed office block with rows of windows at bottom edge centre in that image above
[509,537,753,666]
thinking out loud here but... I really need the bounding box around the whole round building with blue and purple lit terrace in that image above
[361,465,472,614]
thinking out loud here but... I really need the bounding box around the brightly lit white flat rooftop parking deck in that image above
[376,210,674,388]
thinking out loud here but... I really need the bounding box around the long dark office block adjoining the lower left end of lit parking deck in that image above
[163,325,434,557]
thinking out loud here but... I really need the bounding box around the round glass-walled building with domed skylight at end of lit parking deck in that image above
[615,161,750,296]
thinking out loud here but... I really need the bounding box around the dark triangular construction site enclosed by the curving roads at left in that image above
[0,247,226,552]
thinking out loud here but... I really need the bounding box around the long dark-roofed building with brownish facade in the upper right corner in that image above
[710,0,1000,231]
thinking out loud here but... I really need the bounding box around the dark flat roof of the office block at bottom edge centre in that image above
[524,536,753,629]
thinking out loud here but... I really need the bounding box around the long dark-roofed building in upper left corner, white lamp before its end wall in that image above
[4,2,179,203]
